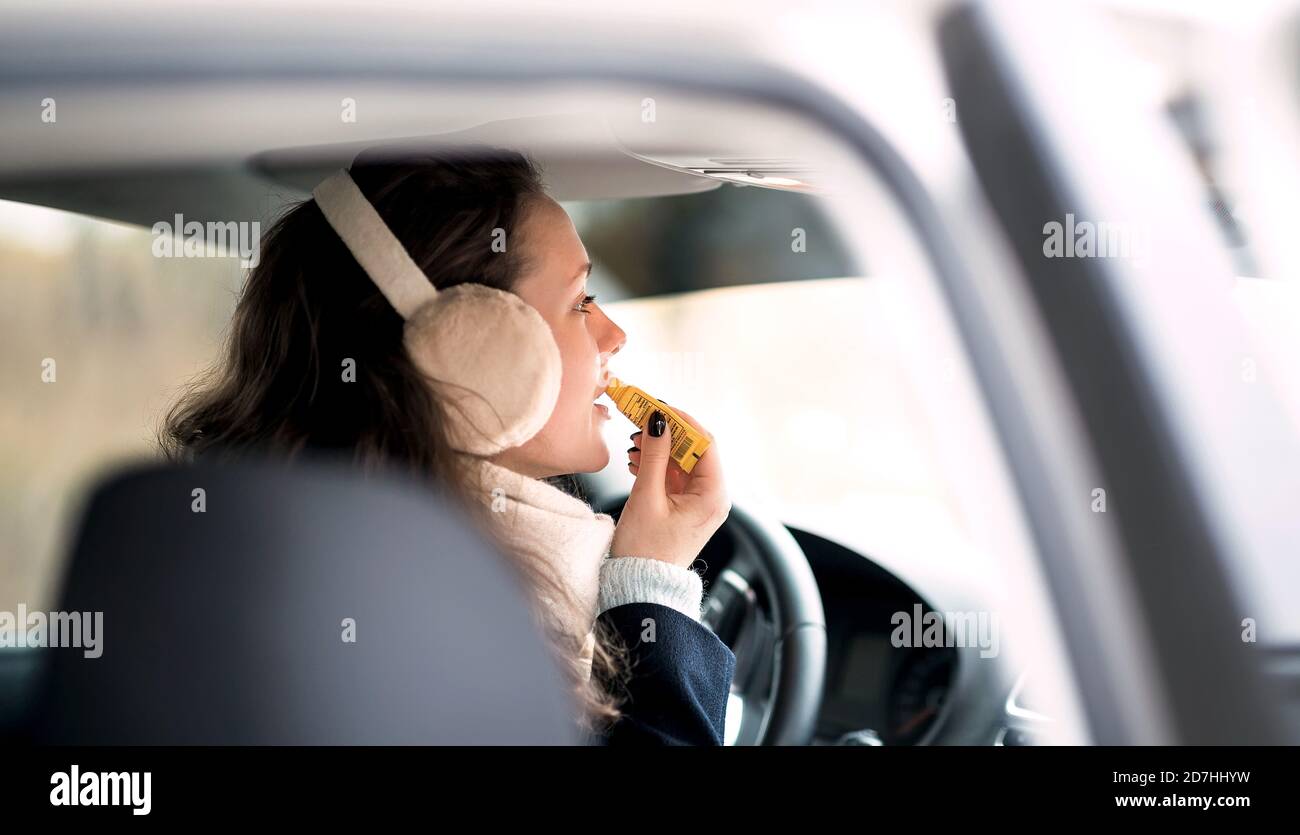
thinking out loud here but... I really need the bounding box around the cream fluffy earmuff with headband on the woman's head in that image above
[312,169,562,455]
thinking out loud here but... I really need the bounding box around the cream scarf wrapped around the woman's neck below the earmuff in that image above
[468,458,614,678]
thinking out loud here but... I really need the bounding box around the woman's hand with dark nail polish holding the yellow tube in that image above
[610,407,731,568]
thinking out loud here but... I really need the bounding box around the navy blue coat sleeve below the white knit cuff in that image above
[592,603,736,745]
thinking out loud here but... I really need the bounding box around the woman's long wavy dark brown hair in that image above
[159,147,628,732]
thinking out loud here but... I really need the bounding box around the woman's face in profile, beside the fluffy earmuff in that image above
[493,196,627,479]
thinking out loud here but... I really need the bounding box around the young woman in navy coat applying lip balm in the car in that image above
[161,148,735,744]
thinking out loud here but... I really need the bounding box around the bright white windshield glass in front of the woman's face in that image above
[590,277,958,561]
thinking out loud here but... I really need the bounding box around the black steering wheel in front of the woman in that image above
[605,494,827,745]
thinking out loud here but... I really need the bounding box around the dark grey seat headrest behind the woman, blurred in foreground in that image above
[31,462,576,745]
